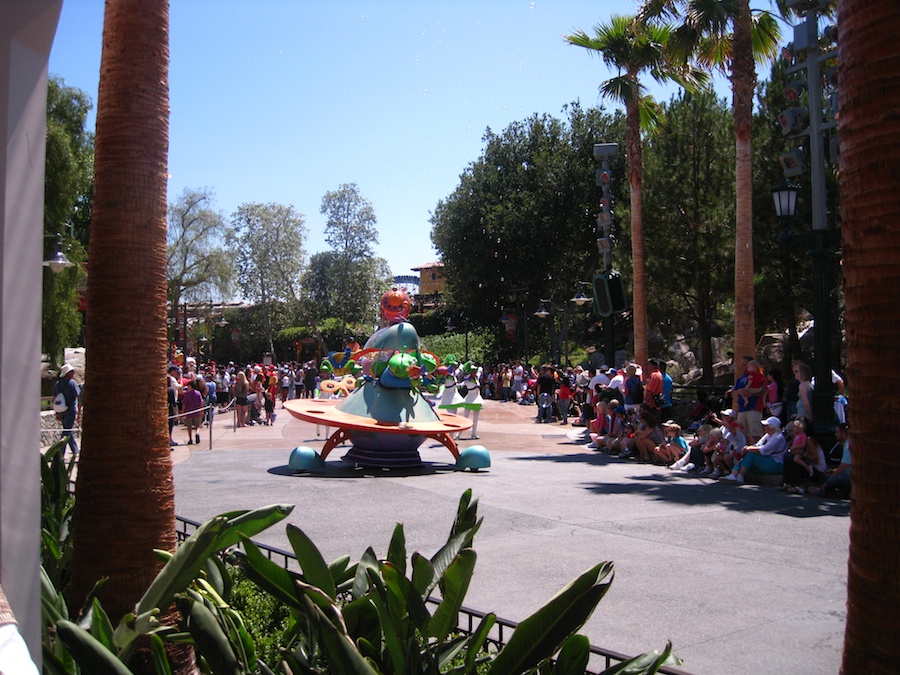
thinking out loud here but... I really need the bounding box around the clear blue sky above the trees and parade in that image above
[50,0,704,275]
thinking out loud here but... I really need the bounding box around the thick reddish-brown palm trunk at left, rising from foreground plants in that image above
[69,0,175,640]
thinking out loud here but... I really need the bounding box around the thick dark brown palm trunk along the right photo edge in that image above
[838,0,900,673]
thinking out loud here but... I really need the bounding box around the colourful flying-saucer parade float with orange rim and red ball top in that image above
[284,288,490,471]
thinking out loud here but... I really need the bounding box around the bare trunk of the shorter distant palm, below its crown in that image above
[625,100,650,372]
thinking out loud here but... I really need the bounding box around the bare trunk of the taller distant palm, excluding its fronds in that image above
[731,0,756,377]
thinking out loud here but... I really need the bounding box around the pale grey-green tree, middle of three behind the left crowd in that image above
[227,203,306,356]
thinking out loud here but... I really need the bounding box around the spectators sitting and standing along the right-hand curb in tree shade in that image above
[568,357,851,497]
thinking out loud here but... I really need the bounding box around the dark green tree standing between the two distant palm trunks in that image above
[644,92,734,384]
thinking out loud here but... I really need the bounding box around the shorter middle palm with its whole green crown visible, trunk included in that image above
[565,16,705,367]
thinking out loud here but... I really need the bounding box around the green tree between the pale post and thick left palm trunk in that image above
[41,77,94,366]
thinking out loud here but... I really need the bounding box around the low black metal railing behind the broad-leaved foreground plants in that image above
[175,516,689,675]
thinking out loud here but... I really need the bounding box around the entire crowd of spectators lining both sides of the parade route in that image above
[54,357,851,497]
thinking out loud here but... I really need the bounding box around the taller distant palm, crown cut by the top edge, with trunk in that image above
[640,0,781,368]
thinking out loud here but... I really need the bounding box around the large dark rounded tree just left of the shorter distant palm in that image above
[431,104,623,354]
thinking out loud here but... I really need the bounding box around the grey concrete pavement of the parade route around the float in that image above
[173,401,850,675]
